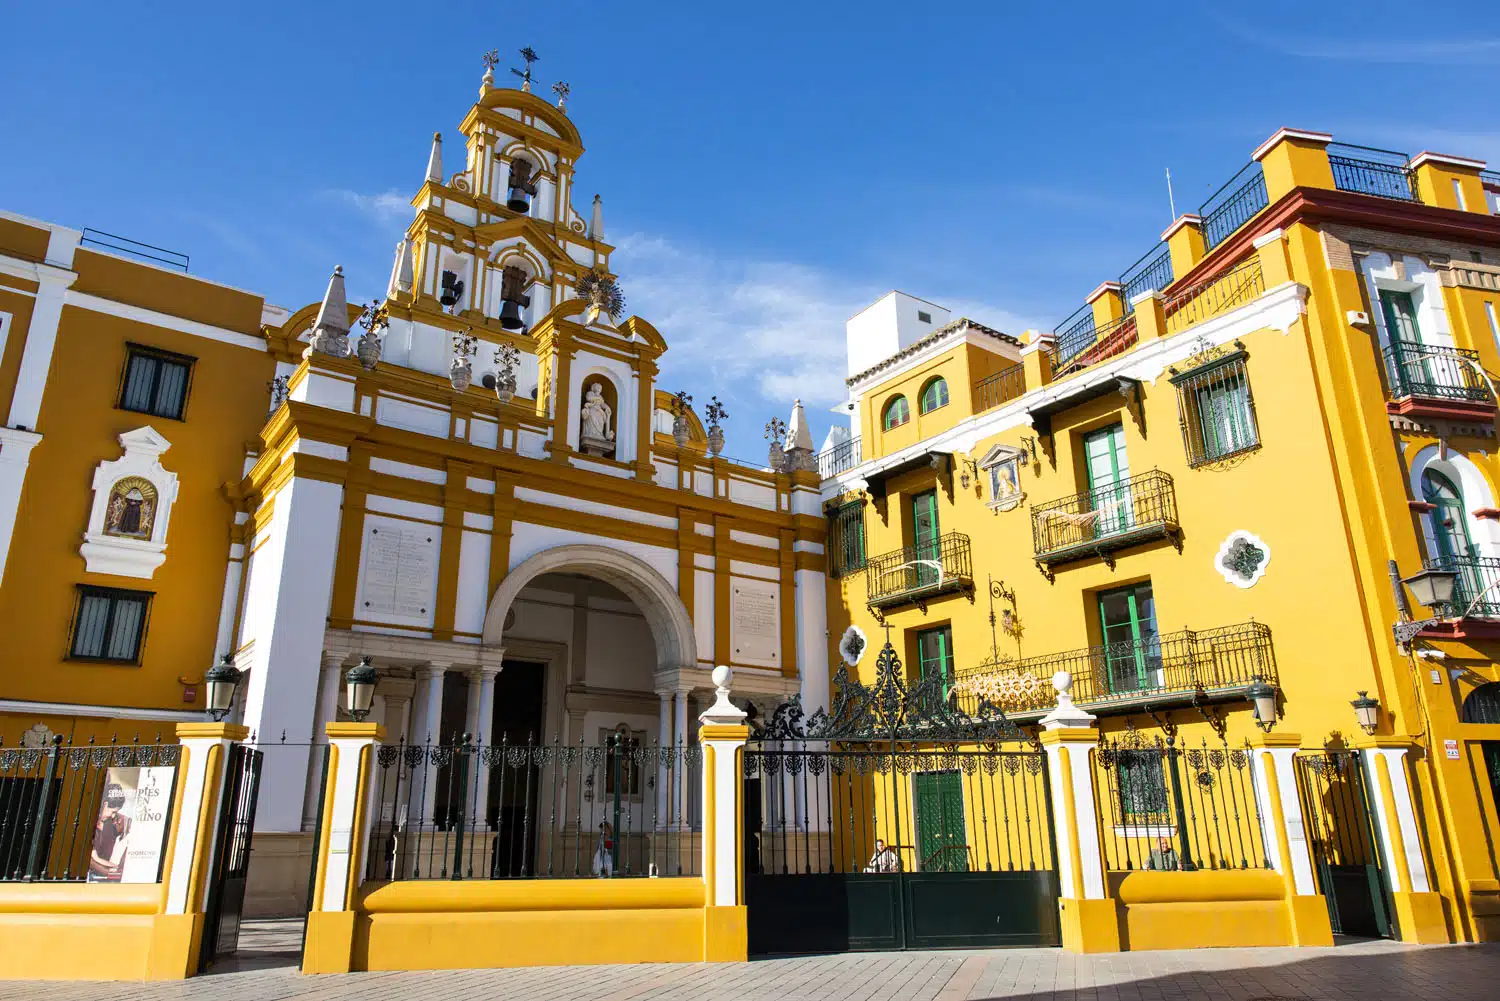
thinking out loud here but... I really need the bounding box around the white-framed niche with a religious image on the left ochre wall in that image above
[78,428,177,581]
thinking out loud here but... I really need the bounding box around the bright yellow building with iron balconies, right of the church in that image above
[810,129,1500,948]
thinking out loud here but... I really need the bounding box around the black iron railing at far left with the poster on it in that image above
[0,735,182,882]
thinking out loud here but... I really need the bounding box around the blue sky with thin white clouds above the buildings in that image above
[0,0,1500,458]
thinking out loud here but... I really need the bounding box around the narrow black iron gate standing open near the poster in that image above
[198,744,264,972]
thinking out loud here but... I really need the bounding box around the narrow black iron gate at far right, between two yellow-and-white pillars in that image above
[1296,749,1394,938]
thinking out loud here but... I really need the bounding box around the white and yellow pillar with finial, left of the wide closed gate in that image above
[698,666,750,962]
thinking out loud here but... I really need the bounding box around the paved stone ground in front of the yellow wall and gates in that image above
[0,941,1500,1001]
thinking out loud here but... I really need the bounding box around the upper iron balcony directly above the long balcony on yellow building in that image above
[1032,470,1178,576]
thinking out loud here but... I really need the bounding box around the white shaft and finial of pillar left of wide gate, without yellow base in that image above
[698,665,749,906]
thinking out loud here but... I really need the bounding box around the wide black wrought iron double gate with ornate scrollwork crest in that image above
[744,642,1061,954]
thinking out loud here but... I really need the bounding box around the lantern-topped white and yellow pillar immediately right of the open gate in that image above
[302,723,386,972]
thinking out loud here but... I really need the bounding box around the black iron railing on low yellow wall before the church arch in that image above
[368,734,704,879]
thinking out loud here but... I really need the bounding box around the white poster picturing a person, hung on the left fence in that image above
[89,767,177,882]
